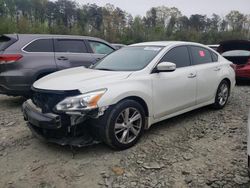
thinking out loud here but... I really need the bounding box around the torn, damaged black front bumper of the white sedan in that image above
[22,100,100,147]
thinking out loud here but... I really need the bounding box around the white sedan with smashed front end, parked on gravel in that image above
[23,41,235,149]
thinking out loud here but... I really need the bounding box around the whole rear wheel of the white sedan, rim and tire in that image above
[213,80,230,109]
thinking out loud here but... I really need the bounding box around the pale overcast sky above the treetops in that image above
[75,0,250,16]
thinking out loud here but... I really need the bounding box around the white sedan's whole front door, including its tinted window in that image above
[152,46,196,119]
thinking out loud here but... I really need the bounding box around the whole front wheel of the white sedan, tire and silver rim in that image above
[94,100,145,150]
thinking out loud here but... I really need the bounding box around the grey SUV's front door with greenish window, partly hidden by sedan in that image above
[87,40,115,63]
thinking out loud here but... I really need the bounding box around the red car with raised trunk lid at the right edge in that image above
[217,40,250,80]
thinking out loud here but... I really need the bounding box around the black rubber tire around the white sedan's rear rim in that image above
[213,80,230,109]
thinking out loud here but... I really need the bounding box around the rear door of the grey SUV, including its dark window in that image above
[54,38,94,70]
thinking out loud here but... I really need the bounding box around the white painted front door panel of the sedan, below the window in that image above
[151,66,196,119]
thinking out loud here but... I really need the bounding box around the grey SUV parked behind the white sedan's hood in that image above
[0,34,115,96]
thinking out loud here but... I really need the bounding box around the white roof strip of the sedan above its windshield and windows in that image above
[130,41,205,47]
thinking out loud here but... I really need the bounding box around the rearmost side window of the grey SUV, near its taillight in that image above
[23,39,54,52]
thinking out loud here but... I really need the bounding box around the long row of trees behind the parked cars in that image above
[0,0,250,44]
